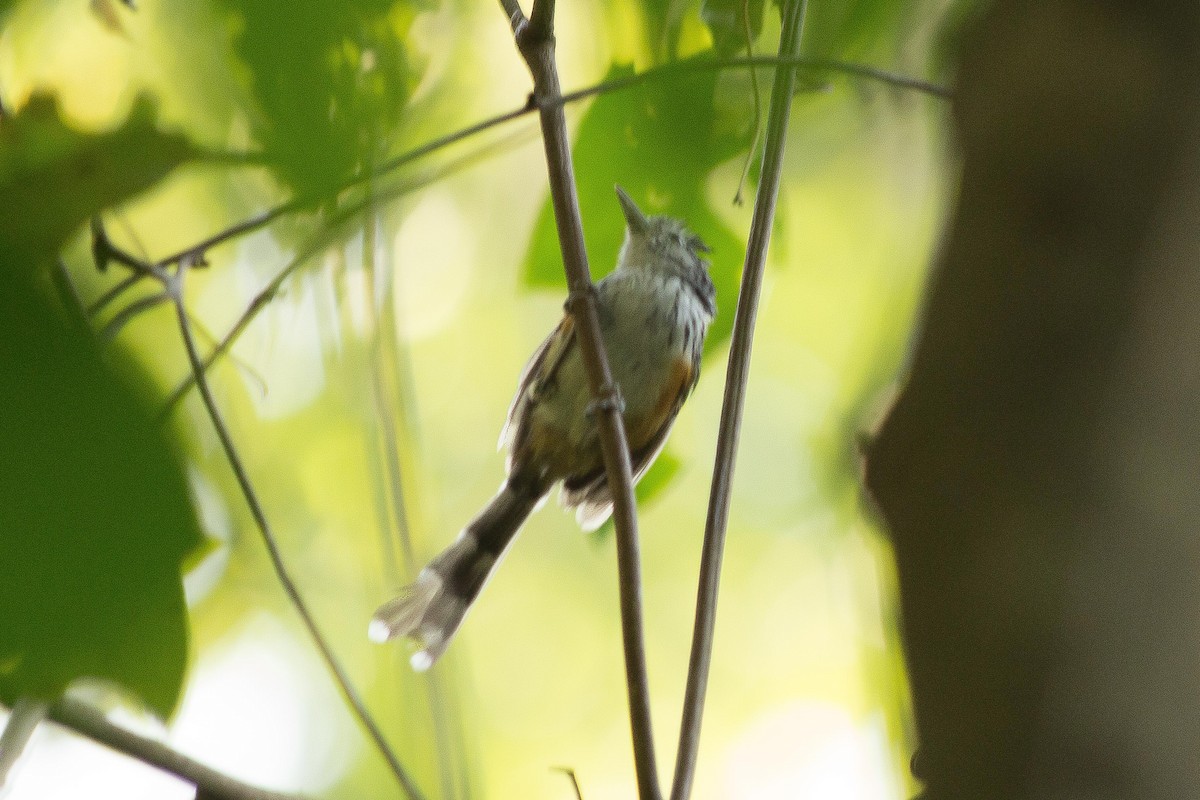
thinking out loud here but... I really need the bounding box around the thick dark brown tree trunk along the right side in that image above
[866,0,1200,800]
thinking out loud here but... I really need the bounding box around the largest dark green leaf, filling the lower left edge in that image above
[0,275,202,717]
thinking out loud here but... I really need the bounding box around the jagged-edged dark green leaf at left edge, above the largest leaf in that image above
[0,95,194,262]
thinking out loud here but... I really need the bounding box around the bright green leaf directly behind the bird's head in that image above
[524,57,750,351]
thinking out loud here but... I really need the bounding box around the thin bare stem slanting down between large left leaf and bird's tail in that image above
[167,275,422,800]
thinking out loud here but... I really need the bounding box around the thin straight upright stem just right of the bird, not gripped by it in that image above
[671,0,808,800]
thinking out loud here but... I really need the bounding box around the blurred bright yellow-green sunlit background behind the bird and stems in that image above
[0,0,953,800]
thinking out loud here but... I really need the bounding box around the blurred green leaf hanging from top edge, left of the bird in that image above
[224,0,420,194]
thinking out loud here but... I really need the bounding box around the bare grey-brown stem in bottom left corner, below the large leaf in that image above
[49,697,299,800]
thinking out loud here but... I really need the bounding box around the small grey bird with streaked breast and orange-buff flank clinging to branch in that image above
[367,186,716,672]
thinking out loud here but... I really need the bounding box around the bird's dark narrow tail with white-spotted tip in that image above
[367,481,546,670]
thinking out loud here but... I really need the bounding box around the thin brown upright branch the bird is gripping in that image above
[500,0,661,800]
